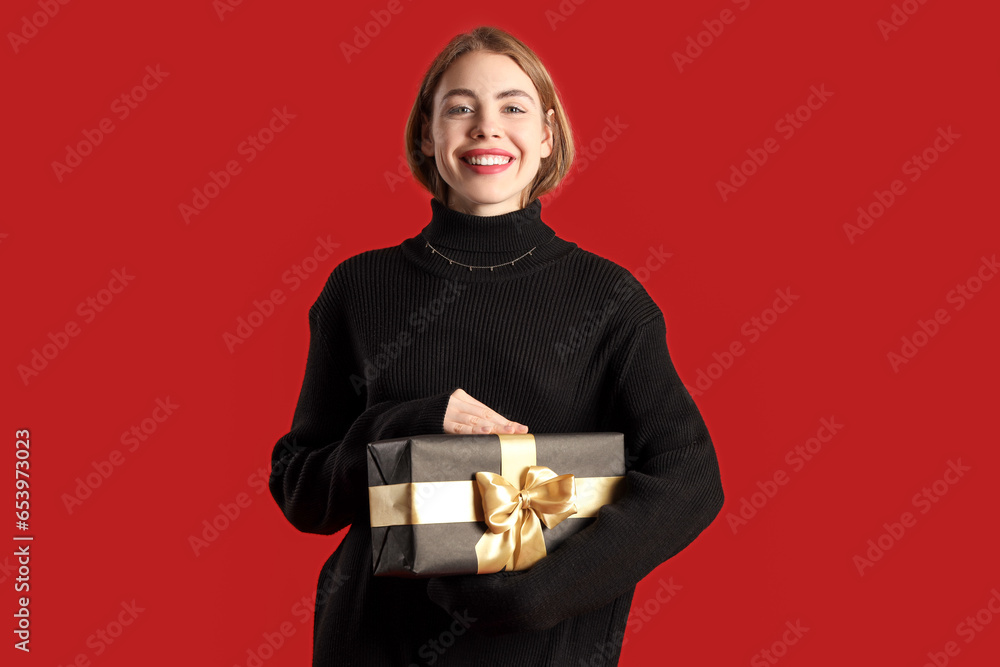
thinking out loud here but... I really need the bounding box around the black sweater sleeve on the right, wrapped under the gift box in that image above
[428,308,723,635]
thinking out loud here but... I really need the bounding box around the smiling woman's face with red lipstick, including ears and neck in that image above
[421,51,555,215]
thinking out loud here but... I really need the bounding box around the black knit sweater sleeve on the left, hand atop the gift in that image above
[268,276,457,535]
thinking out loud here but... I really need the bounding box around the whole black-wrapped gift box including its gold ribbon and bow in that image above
[368,432,625,578]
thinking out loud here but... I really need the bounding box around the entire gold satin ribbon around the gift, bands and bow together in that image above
[368,433,625,574]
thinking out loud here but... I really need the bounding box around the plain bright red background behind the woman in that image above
[0,0,1000,667]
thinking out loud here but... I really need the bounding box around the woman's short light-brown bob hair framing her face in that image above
[405,26,574,208]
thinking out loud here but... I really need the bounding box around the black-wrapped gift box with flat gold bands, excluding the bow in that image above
[368,432,626,578]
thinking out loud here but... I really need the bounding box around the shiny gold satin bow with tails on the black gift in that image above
[476,465,577,573]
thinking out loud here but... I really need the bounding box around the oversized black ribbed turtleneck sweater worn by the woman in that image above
[270,199,723,667]
